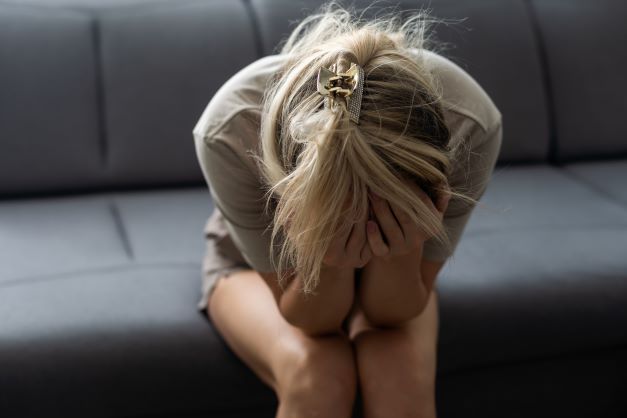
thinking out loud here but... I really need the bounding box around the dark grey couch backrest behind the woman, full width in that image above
[0,0,627,196]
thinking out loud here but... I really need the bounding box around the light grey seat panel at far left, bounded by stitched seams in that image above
[0,195,128,284]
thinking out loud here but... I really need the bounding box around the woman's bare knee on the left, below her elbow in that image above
[277,336,358,416]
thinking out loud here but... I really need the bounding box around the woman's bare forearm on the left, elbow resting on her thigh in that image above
[279,267,355,335]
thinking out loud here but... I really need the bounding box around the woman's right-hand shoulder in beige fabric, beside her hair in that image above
[410,49,502,131]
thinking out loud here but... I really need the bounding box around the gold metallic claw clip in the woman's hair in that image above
[317,62,364,124]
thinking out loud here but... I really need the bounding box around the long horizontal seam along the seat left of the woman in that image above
[0,262,201,289]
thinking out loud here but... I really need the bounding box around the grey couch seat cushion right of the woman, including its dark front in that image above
[436,166,627,372]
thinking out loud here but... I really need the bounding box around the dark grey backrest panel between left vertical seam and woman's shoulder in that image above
[100,0,256,185]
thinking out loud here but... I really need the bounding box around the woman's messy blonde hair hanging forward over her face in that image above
[257,0,475,293]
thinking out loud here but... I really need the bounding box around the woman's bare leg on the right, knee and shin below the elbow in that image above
[349,291,438,418]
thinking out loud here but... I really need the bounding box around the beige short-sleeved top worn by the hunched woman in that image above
[193,51,502,271]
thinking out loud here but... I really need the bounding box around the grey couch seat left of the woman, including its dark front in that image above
[0,187,275,417]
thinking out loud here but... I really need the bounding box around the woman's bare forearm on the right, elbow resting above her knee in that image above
[358,246,428,326]
